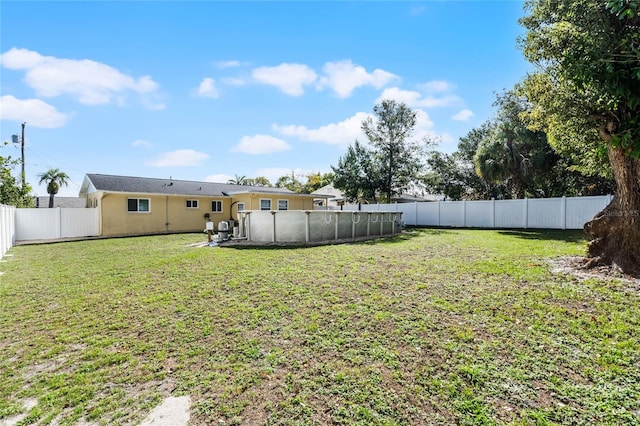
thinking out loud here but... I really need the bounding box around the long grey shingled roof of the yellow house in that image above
[80,173,320,197]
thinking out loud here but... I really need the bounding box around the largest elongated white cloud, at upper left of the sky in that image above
[0,47,164,109]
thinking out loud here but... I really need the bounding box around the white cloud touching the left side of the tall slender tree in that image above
[273,112,370,146]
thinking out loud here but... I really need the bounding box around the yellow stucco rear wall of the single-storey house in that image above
[97,193,313,236]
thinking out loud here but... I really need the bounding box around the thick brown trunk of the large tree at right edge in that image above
[584,148,640,277]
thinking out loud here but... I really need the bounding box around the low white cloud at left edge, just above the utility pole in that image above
[0,95,70,129]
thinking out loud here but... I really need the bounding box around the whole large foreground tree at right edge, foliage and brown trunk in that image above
[520,0,640,275]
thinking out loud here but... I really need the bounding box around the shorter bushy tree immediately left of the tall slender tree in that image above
[331,140,383,202]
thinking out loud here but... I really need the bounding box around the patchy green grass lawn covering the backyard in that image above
[0,230,640,425]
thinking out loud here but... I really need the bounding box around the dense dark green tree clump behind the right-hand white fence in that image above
[424,91,615,200]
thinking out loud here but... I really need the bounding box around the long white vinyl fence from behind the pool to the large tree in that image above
[332,195,612,229]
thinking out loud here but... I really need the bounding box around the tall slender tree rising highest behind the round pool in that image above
[362,100,423,203]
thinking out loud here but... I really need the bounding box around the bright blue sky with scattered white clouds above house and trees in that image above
[0,0,530,196]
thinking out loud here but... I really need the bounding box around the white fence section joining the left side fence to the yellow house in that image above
[15,208,100,241]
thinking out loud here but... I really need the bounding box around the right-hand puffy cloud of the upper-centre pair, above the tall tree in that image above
[319,60,398,98]
